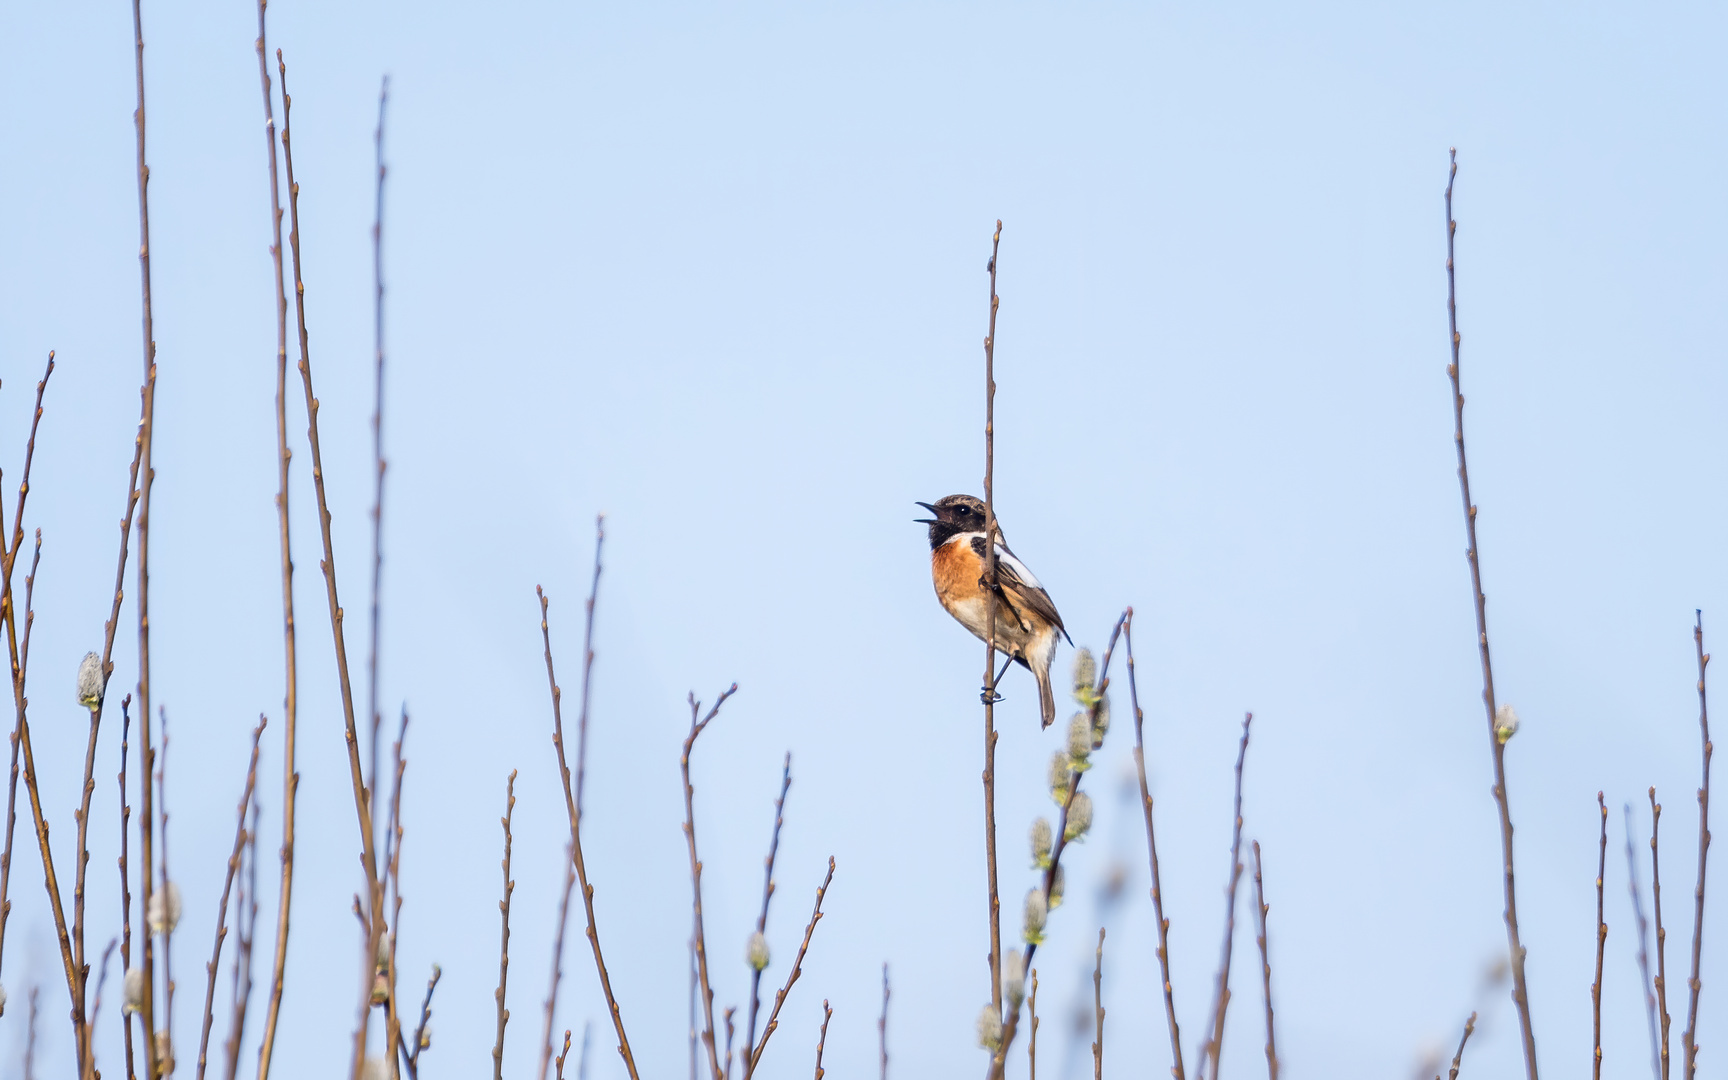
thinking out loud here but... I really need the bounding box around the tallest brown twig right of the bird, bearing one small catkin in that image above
[1446,150,1536,1080]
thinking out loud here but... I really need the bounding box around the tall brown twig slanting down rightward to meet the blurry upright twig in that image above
[276,48,385,1080]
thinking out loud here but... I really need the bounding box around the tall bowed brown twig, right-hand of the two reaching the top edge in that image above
[247,8,301,1080]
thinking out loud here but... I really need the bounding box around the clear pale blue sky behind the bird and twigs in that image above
[0,0,1728,1078]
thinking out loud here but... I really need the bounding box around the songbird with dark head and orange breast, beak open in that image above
[918,494,1073,727]
